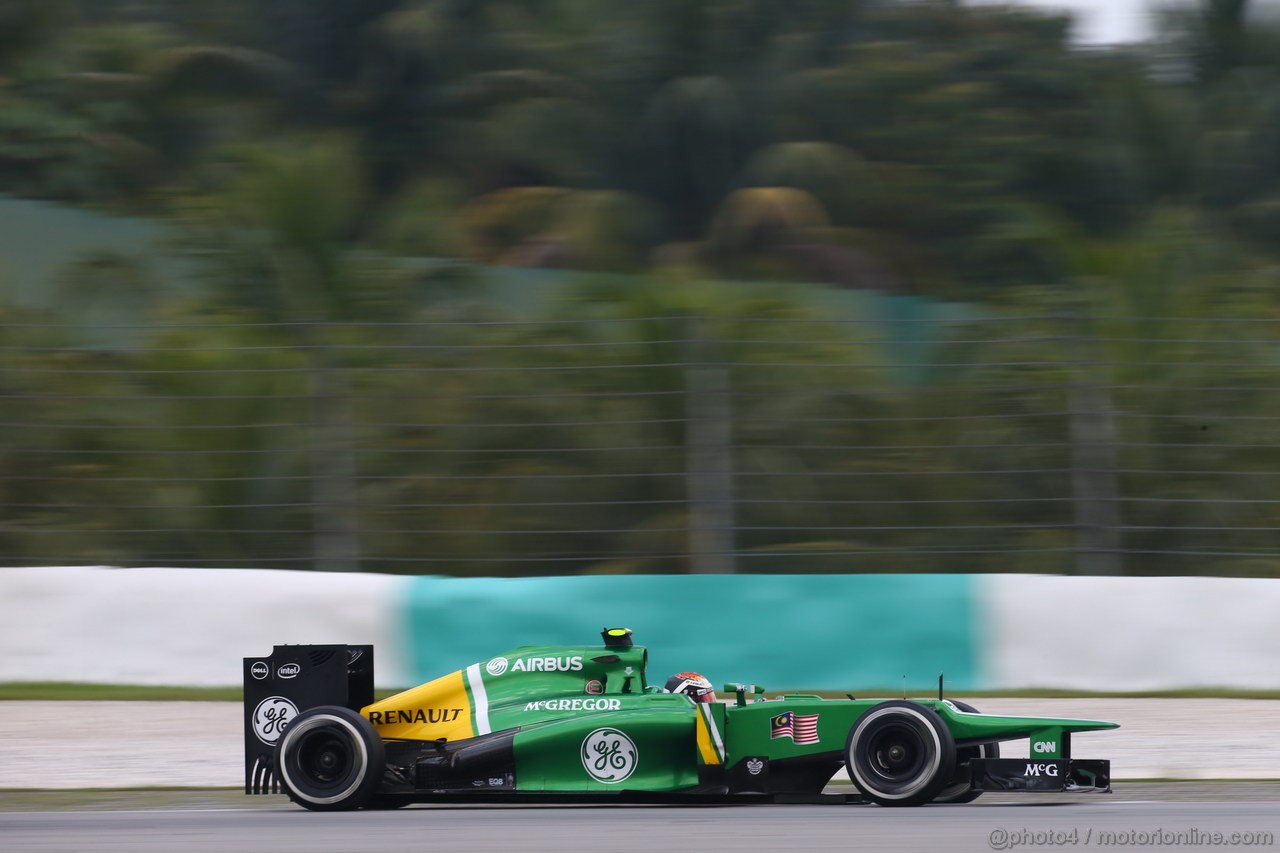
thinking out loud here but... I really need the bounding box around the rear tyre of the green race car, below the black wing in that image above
[275,706,387,812]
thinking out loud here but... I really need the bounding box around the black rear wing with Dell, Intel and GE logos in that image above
[244,646,374,794]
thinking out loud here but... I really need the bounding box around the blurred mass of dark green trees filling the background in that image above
[0,0,1280,574]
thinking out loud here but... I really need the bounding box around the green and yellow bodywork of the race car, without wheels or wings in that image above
[362,635,1116,793]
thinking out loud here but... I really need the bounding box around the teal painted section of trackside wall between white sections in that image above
[406,575,979,690]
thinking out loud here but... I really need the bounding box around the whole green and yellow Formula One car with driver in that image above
[244,629,1116,811]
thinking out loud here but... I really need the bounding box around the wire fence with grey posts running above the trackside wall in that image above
[0,313,1280,575]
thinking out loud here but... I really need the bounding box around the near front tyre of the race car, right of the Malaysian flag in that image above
[845,701,956,806]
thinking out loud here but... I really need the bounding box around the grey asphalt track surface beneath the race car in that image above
[0,783,1280,853]
